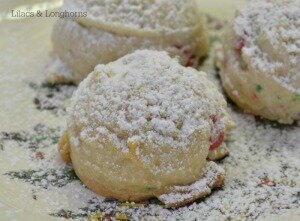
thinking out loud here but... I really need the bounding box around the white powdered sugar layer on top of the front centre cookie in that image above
[69,50,228,151]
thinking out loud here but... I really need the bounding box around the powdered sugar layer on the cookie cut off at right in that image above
[234,0,300,93]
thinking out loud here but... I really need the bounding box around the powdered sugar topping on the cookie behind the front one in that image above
[65,0,199,35]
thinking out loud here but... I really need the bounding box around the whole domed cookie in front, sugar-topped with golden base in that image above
[59,50,231,207]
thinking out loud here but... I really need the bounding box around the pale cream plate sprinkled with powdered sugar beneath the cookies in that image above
[0,0,300,221]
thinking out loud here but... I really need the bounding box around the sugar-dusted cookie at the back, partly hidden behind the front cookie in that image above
[46,0,208,83]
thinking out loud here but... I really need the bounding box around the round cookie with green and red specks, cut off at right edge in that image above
[219,0,300,124]
